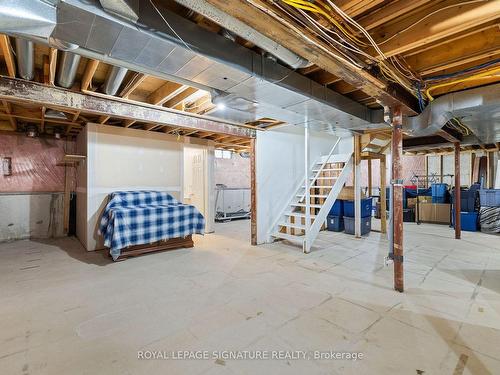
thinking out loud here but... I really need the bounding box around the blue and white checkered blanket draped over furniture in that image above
[98,191,205,260]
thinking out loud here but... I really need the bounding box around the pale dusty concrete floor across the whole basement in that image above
[0,221,500,375]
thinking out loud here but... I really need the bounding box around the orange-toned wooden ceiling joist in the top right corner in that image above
[373,0,500,57]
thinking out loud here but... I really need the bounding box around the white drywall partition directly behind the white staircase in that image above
[255,126,342,244]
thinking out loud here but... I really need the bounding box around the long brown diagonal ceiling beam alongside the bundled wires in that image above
[202,0,418,115]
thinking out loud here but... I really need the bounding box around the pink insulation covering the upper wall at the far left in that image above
[0,132,75,193]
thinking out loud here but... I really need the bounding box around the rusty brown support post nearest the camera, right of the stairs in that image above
[392,106,404,292]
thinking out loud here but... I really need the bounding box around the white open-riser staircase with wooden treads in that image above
[270,142,353,253]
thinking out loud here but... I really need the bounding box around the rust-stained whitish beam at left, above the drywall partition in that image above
[0,77,257,138]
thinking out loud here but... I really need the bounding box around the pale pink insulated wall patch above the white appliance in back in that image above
[215,154,250,188]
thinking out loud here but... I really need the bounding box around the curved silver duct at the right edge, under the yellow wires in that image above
[403,84,500,144]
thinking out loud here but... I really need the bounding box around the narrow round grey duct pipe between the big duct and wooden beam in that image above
[175,0,312,69]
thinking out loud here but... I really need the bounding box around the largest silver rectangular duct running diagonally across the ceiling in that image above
[0,0,388,132]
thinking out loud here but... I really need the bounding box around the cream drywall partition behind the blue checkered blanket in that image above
[78,124,213,251]
